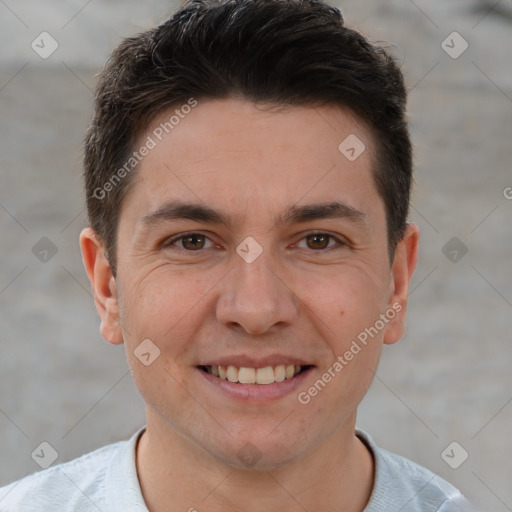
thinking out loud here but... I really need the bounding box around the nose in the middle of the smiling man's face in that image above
[216,251,299,335]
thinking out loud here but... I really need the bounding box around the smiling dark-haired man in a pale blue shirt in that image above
[0,0,469,512]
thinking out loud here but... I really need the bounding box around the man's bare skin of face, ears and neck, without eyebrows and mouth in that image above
[80,99,419,512]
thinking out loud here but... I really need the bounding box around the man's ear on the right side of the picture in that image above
[384,224,420,345]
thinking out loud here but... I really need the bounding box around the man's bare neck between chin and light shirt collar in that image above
[136,411,374,512]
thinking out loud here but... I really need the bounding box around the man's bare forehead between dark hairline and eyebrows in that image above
[121,99,376,224]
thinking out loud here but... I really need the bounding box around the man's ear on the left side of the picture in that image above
[80,228,123,345]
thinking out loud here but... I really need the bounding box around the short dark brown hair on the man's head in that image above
[84,0,412,276]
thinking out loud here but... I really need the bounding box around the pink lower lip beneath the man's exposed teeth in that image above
[196,366,314,402]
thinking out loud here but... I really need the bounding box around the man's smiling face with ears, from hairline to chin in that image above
[81,99,417,467]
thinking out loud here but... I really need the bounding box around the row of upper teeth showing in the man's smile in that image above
[206,364,301,384]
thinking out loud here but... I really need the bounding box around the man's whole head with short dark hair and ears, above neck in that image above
[81,0,418,465]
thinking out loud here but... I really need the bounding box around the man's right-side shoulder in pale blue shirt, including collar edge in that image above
[356,429,470,512]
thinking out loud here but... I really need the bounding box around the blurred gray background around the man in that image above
[0,0,512,511]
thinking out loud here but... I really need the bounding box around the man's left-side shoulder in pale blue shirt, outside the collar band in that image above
[0,441,128,512]
